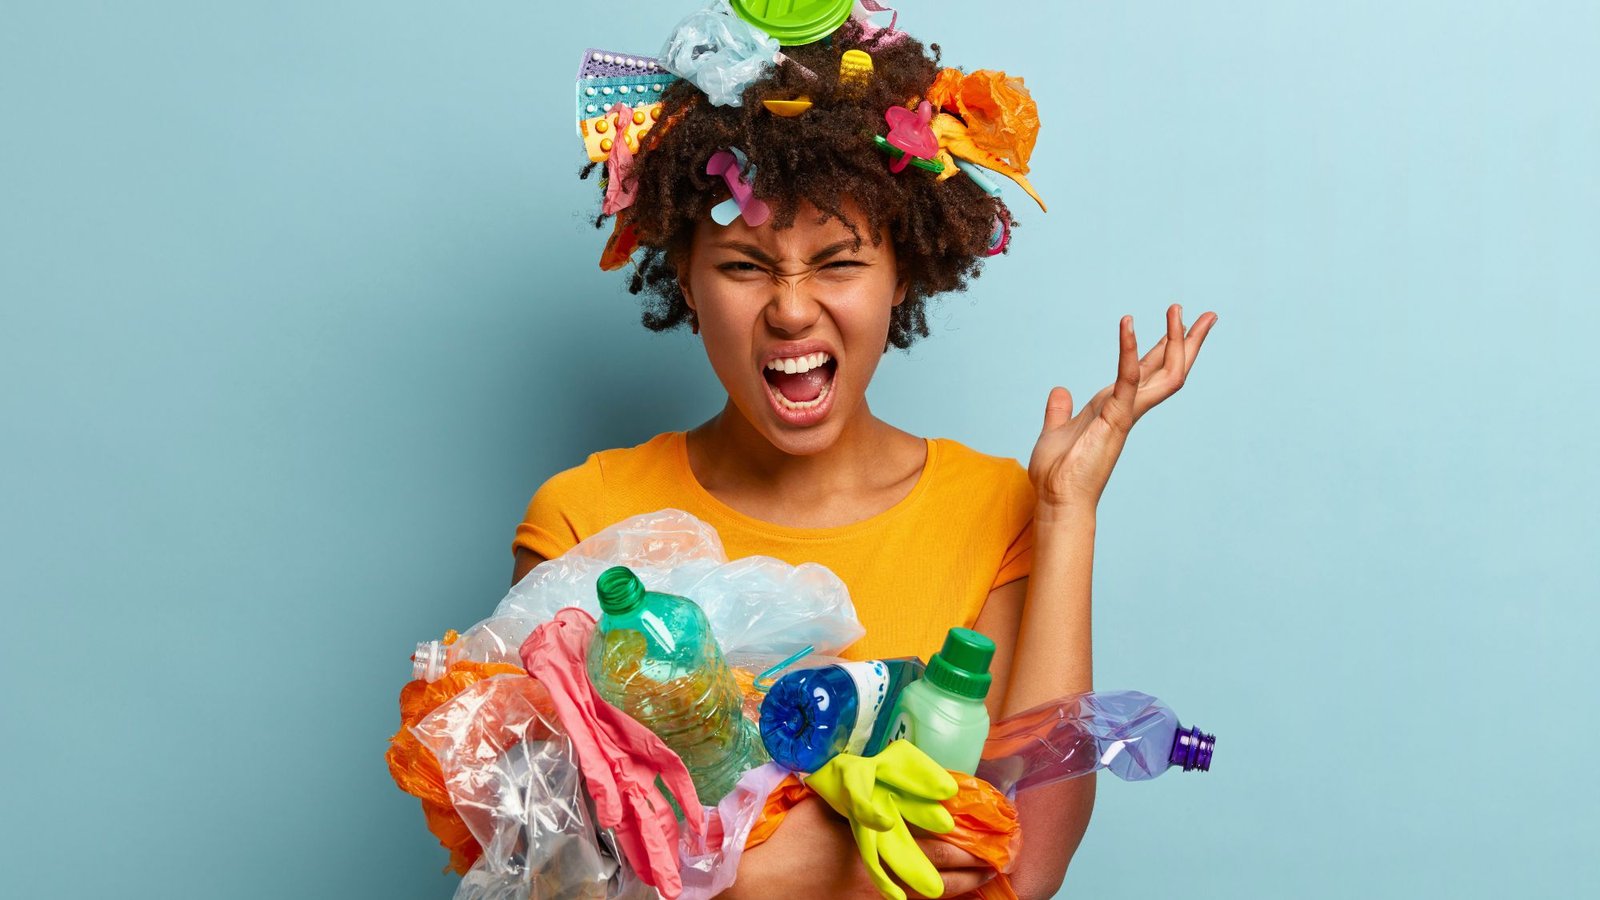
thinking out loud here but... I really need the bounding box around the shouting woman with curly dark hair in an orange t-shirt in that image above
[515,19,1216,898]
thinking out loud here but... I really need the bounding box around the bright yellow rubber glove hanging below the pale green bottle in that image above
[806,740,957,900]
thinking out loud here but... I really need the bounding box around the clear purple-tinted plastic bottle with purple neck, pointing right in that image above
[978,690,1216,791]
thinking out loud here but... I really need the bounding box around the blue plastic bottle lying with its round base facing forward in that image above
[762,657,923,772]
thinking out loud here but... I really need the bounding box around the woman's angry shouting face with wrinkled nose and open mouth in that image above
[682,202,906,455]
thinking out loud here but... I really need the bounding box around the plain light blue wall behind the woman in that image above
[0,0,1600,898]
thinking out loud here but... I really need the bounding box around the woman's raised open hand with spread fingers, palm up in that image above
[1027,303,1216,512]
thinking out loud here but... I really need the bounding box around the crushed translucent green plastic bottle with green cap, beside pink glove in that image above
[589,565,766,806]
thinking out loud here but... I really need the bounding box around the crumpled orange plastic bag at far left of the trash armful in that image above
[384,650,528,874]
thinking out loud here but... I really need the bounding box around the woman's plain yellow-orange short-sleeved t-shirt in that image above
[512,431,1034,660]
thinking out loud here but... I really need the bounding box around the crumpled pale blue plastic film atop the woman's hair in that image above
[658,0,779,106]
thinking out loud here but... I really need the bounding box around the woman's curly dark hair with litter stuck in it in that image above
[582,19,1016,351]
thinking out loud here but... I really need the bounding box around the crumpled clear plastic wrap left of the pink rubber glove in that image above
[411,674,616,900]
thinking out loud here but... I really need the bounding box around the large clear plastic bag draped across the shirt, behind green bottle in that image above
[492,509,866,650]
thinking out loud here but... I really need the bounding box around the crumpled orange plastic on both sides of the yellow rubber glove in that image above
[744,772,1022,900]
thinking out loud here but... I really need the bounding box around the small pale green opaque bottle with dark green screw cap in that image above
[890,628,995,775]
